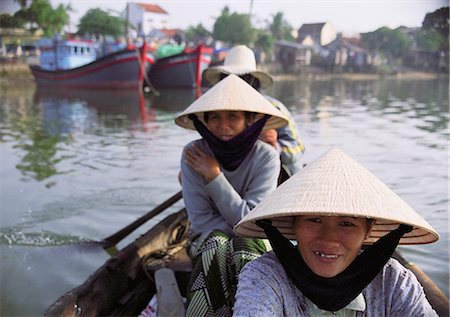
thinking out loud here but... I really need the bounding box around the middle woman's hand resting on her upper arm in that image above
[184,144,221,183]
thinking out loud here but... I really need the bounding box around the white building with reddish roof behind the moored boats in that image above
[125,2,169,36]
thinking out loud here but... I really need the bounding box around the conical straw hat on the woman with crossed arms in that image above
[175,75,288,130]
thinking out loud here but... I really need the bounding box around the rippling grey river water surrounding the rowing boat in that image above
[0,78,449,316]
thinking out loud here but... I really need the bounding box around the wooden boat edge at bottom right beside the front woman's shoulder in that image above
[392,250,449,316]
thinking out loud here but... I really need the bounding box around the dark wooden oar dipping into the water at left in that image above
[100,191,182,249]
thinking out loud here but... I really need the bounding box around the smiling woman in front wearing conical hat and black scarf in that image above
[234,148,439,316]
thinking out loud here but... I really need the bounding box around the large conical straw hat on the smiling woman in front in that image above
[234,148,439,244]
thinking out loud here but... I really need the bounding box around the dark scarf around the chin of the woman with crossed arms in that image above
[189,114,270,171]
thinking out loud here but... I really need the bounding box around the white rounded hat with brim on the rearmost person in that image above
[202,45,273,88]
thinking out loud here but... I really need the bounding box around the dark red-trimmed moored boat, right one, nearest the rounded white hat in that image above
[148,44,213,88]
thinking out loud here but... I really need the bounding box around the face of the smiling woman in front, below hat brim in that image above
[294,215,372,278]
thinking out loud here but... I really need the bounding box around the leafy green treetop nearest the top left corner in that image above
[14,0,72,37]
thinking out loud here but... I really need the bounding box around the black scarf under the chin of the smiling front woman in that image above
[256,220,412,311]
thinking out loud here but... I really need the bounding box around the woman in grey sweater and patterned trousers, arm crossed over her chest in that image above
[175,75,287,316]
